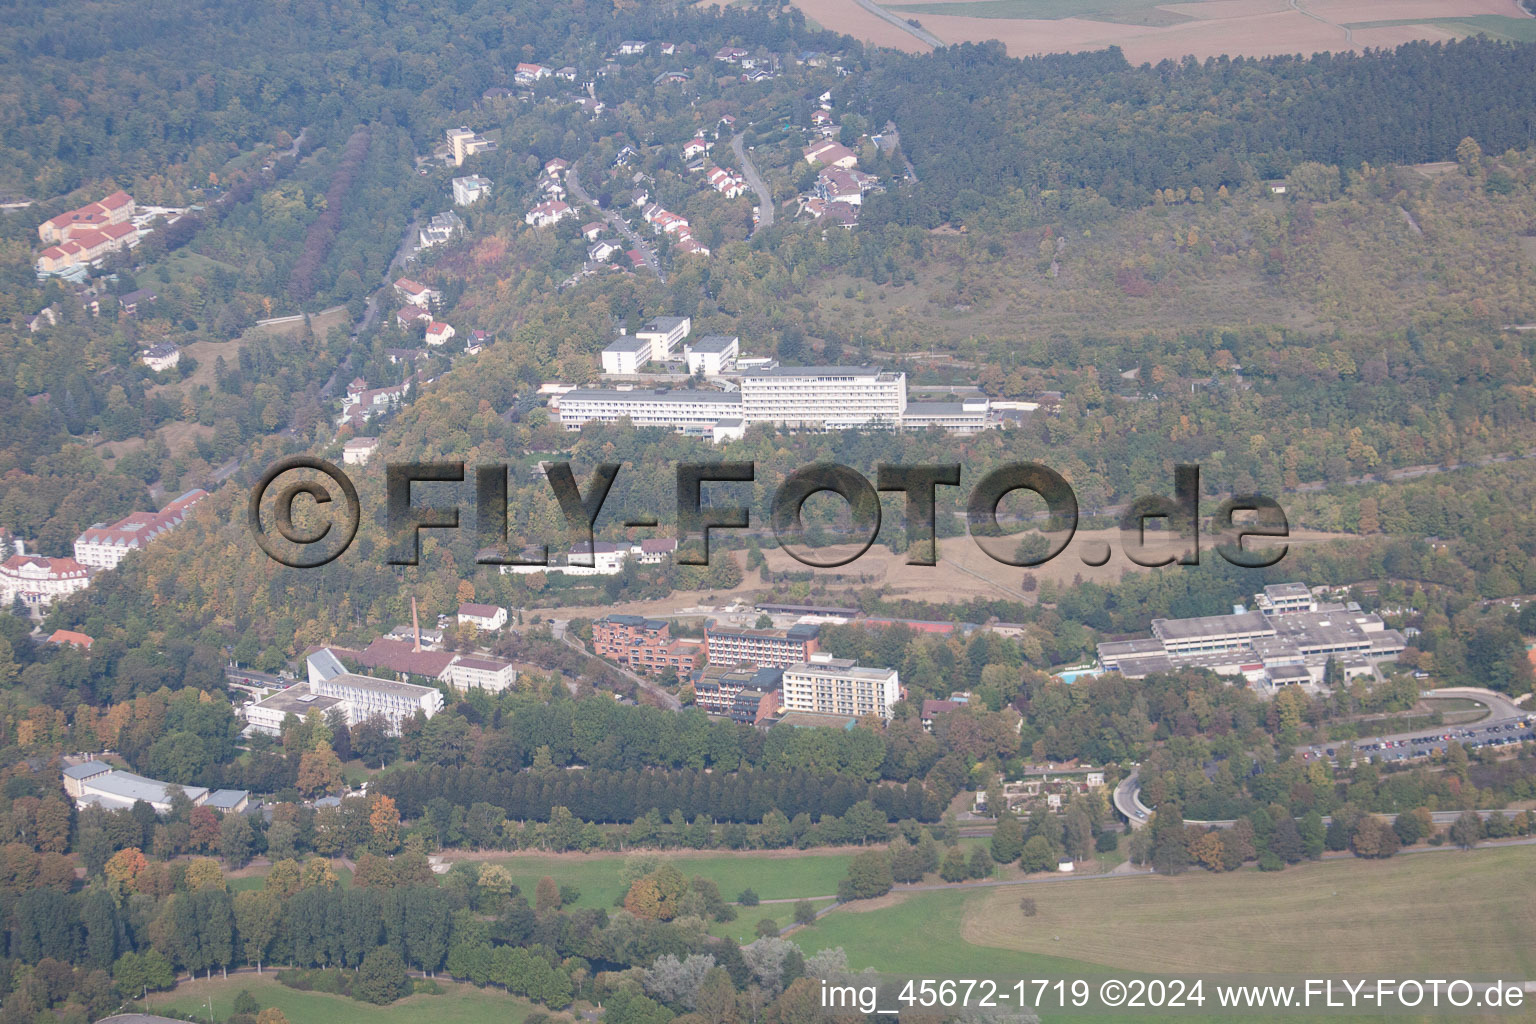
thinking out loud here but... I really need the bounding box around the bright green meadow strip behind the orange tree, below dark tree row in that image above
[454,851,854,908]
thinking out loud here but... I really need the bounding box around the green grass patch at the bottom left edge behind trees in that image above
[131,972,549,1024]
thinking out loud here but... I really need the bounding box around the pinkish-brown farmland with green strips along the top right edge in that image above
[802,0,1536,63]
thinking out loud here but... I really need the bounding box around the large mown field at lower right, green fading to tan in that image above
[796,846,1536,978]
